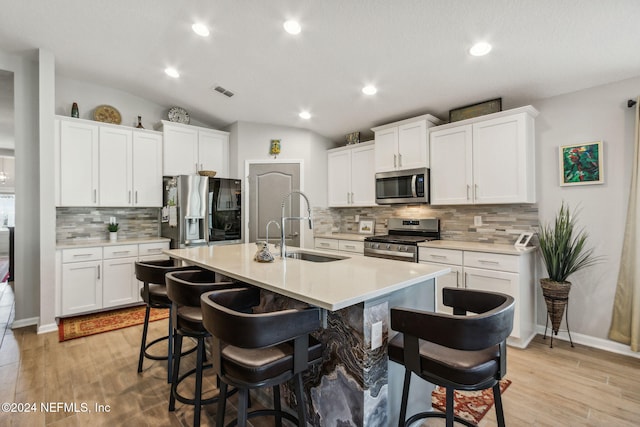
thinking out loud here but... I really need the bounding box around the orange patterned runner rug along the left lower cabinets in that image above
[58,306,169,342]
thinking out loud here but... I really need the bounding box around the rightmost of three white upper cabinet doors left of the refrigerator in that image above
[132,132,162,207]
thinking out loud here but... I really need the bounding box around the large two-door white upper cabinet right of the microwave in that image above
[430,106,538,205]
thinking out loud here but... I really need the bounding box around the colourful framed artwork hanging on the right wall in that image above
[559,141,604,186]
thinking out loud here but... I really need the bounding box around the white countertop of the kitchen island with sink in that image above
[163,243,450,311]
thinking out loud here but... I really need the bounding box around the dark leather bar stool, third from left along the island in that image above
[201,288,322,427]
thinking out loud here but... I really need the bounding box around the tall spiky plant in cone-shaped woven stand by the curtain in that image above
[538,202,600,335]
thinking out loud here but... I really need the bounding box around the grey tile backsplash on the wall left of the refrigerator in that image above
[56,207,160,243]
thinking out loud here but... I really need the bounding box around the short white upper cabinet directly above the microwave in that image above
[372,114,441,172]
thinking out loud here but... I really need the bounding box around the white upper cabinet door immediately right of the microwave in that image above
[430,125,472,205]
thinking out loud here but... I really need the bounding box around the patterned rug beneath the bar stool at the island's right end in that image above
[431,378,511,424]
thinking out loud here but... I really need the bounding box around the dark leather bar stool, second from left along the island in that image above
[165,270,240,426]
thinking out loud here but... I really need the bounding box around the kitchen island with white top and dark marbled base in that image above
[164,243,450,426]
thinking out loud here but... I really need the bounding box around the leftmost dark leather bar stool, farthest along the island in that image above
[135,259,195,382]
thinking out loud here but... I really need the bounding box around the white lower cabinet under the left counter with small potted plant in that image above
[56,242,169,316]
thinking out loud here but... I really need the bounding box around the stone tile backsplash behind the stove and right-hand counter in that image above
[313,204,538,244]
